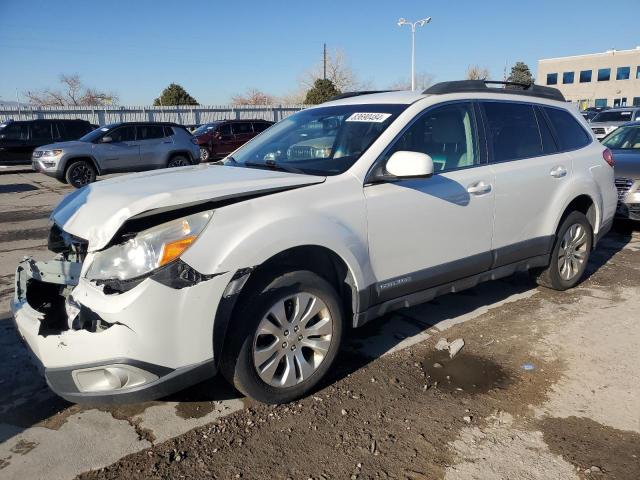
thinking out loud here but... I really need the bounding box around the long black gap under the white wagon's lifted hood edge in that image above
[105,182,322,246]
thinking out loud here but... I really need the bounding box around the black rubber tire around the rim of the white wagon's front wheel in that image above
[221,270,344,404]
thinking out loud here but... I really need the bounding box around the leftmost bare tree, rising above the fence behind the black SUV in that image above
[24,74,118,107]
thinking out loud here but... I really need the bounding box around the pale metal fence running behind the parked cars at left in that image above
[0,105,305,126]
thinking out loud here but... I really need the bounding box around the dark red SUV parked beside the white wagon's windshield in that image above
[193,120,273,162]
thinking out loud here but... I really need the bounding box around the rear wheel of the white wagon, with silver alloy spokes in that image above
[532,212,593,290]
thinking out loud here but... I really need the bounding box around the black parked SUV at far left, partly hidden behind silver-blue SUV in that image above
[0,120,93,164]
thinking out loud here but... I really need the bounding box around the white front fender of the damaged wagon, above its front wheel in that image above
[182,173,373,289]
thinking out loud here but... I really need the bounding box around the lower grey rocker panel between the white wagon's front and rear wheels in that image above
[354,255,550,328]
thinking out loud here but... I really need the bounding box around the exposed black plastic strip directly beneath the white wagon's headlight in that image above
[92,258,227,295]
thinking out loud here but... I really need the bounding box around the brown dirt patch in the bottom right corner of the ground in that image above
[539,417,640,480]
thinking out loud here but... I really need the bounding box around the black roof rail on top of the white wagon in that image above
[422,80,566,102]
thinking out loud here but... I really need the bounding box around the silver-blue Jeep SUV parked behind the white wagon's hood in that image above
[31,123,200,188]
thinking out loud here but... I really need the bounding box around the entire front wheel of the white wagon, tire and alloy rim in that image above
[221,270,344,404]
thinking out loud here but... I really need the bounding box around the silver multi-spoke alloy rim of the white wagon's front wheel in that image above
[253,292,333,388]
